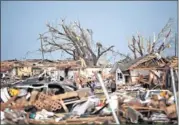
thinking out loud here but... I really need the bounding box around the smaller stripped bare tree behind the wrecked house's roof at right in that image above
[128,18,174,59]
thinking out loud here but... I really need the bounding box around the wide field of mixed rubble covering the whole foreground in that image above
[1,57,178,124]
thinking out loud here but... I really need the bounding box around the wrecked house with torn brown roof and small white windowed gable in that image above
[110,54,168,83]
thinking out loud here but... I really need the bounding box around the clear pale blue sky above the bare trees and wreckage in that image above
[1,1,177,60]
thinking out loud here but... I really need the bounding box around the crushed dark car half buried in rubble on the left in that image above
[1,78,90,102]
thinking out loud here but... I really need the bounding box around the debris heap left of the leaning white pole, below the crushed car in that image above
[1,83,113,124]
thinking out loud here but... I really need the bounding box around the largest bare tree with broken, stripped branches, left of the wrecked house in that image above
[39,20,114,65]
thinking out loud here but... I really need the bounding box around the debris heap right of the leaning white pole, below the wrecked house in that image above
[119,90,177,123]
